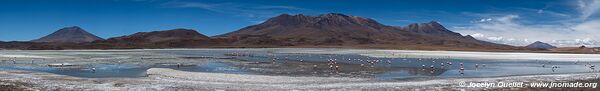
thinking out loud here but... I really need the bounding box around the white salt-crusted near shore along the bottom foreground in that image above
[0,68,600,91]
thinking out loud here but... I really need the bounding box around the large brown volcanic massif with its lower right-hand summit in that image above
[217,13,515,48]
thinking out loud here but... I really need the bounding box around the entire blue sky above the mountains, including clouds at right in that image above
[0,0,600,46]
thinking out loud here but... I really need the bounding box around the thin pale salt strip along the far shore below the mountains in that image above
[5,48,600,62]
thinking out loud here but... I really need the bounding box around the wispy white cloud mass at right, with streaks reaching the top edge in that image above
[452,0,600,46]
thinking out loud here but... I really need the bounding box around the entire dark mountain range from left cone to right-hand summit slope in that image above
[2,13,527,50]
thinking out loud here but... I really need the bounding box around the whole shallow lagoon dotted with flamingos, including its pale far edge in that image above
[0,48,600,80]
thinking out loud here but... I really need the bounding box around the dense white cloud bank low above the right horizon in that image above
[453,14,600,46]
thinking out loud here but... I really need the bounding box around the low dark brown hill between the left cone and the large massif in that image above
[95,29,218,49]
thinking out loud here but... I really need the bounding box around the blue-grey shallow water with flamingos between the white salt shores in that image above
[0,50,600,79]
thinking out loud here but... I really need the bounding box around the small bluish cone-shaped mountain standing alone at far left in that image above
[32,26,103,43]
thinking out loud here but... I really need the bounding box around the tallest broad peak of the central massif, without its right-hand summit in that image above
[222,13,401,44]
